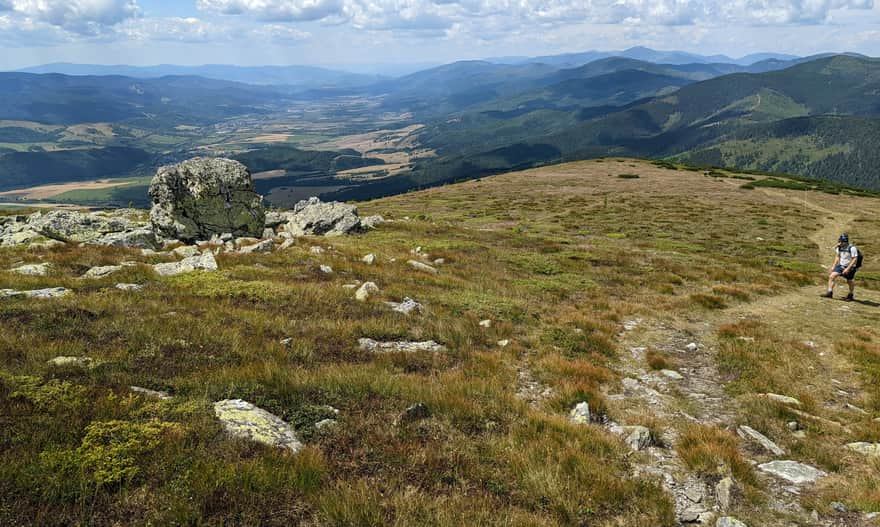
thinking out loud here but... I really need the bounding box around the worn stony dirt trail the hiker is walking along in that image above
[606,189,880,525]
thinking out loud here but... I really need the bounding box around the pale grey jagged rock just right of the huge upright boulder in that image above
[280,197,361,236]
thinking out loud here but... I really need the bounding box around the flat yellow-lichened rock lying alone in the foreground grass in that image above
[214,399,303,453]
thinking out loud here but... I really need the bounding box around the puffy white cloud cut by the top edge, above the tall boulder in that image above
[196,0,345,22]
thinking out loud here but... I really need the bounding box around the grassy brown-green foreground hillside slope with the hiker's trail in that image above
[0,159,880,527]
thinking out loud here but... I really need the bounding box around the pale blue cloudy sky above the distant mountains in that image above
[0,0,880,69]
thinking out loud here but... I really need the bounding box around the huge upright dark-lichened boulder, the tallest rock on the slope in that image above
[150,157,266,241]
